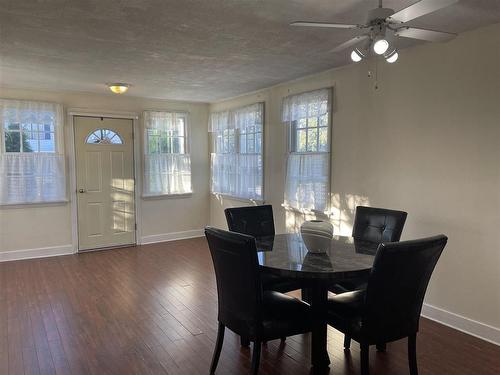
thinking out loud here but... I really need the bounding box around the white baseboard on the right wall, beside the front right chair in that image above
[422,303,500,345]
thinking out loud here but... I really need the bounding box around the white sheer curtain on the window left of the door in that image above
[0,99,67,204]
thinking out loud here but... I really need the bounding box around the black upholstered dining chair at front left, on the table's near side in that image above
[205,227,311,374]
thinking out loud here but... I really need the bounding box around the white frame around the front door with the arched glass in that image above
[66,108,142,253]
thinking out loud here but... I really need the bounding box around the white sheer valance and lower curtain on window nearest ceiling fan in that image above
[282,89,331,212]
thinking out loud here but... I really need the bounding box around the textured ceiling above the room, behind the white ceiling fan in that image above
[0,0,500,101]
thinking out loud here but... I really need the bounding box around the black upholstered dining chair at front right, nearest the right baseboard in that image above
[328,235,448,375]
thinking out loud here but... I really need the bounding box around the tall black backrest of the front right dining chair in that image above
[363,235,448,342]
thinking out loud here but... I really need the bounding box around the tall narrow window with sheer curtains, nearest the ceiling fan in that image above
[282,89,331,212]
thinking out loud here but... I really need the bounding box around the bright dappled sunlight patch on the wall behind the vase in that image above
[285,194,370,236]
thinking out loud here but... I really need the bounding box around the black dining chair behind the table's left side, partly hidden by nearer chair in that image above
[224,204,301,293]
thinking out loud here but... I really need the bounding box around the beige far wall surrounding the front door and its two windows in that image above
[0,88,209,253]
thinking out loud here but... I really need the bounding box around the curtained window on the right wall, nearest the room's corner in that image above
[210,103,264,200]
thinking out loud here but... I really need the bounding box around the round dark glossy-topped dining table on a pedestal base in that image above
[256,234,379,370]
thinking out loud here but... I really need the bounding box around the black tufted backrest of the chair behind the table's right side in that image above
[352,206,408,242]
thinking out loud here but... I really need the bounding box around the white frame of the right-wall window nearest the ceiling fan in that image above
[282,87,334,217]
